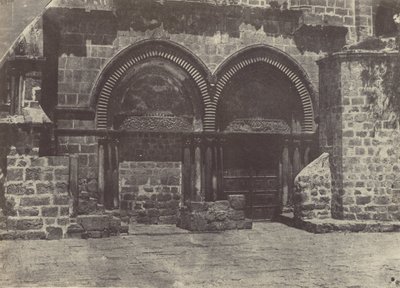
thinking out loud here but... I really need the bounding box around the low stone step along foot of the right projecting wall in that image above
[276,213,400,233]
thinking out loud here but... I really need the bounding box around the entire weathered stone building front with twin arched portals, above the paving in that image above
[0,0,400,239]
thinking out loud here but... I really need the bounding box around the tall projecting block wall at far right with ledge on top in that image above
[320,53,400,221]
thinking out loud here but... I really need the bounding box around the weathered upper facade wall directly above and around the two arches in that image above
[47,1,340,116]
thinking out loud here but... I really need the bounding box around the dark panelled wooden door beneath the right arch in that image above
[223,135,281,219]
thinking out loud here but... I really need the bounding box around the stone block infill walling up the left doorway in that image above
[119,161,182,224]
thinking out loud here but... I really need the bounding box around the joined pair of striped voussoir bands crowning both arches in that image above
[94,42,314,133]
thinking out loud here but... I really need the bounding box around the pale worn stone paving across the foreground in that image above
[0,223,400,288]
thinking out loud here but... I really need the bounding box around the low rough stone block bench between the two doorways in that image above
[177,195,252,231]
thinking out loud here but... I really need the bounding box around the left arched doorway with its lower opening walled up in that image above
[94,40,210,210]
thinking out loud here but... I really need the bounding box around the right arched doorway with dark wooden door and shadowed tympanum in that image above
[216,47,315,219]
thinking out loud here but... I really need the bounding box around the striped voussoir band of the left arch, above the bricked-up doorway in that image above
[92,40,212,129]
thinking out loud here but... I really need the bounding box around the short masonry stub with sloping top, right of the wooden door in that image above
[294,153,332,219]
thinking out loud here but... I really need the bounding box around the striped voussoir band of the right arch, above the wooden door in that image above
[211,45,315,133]
